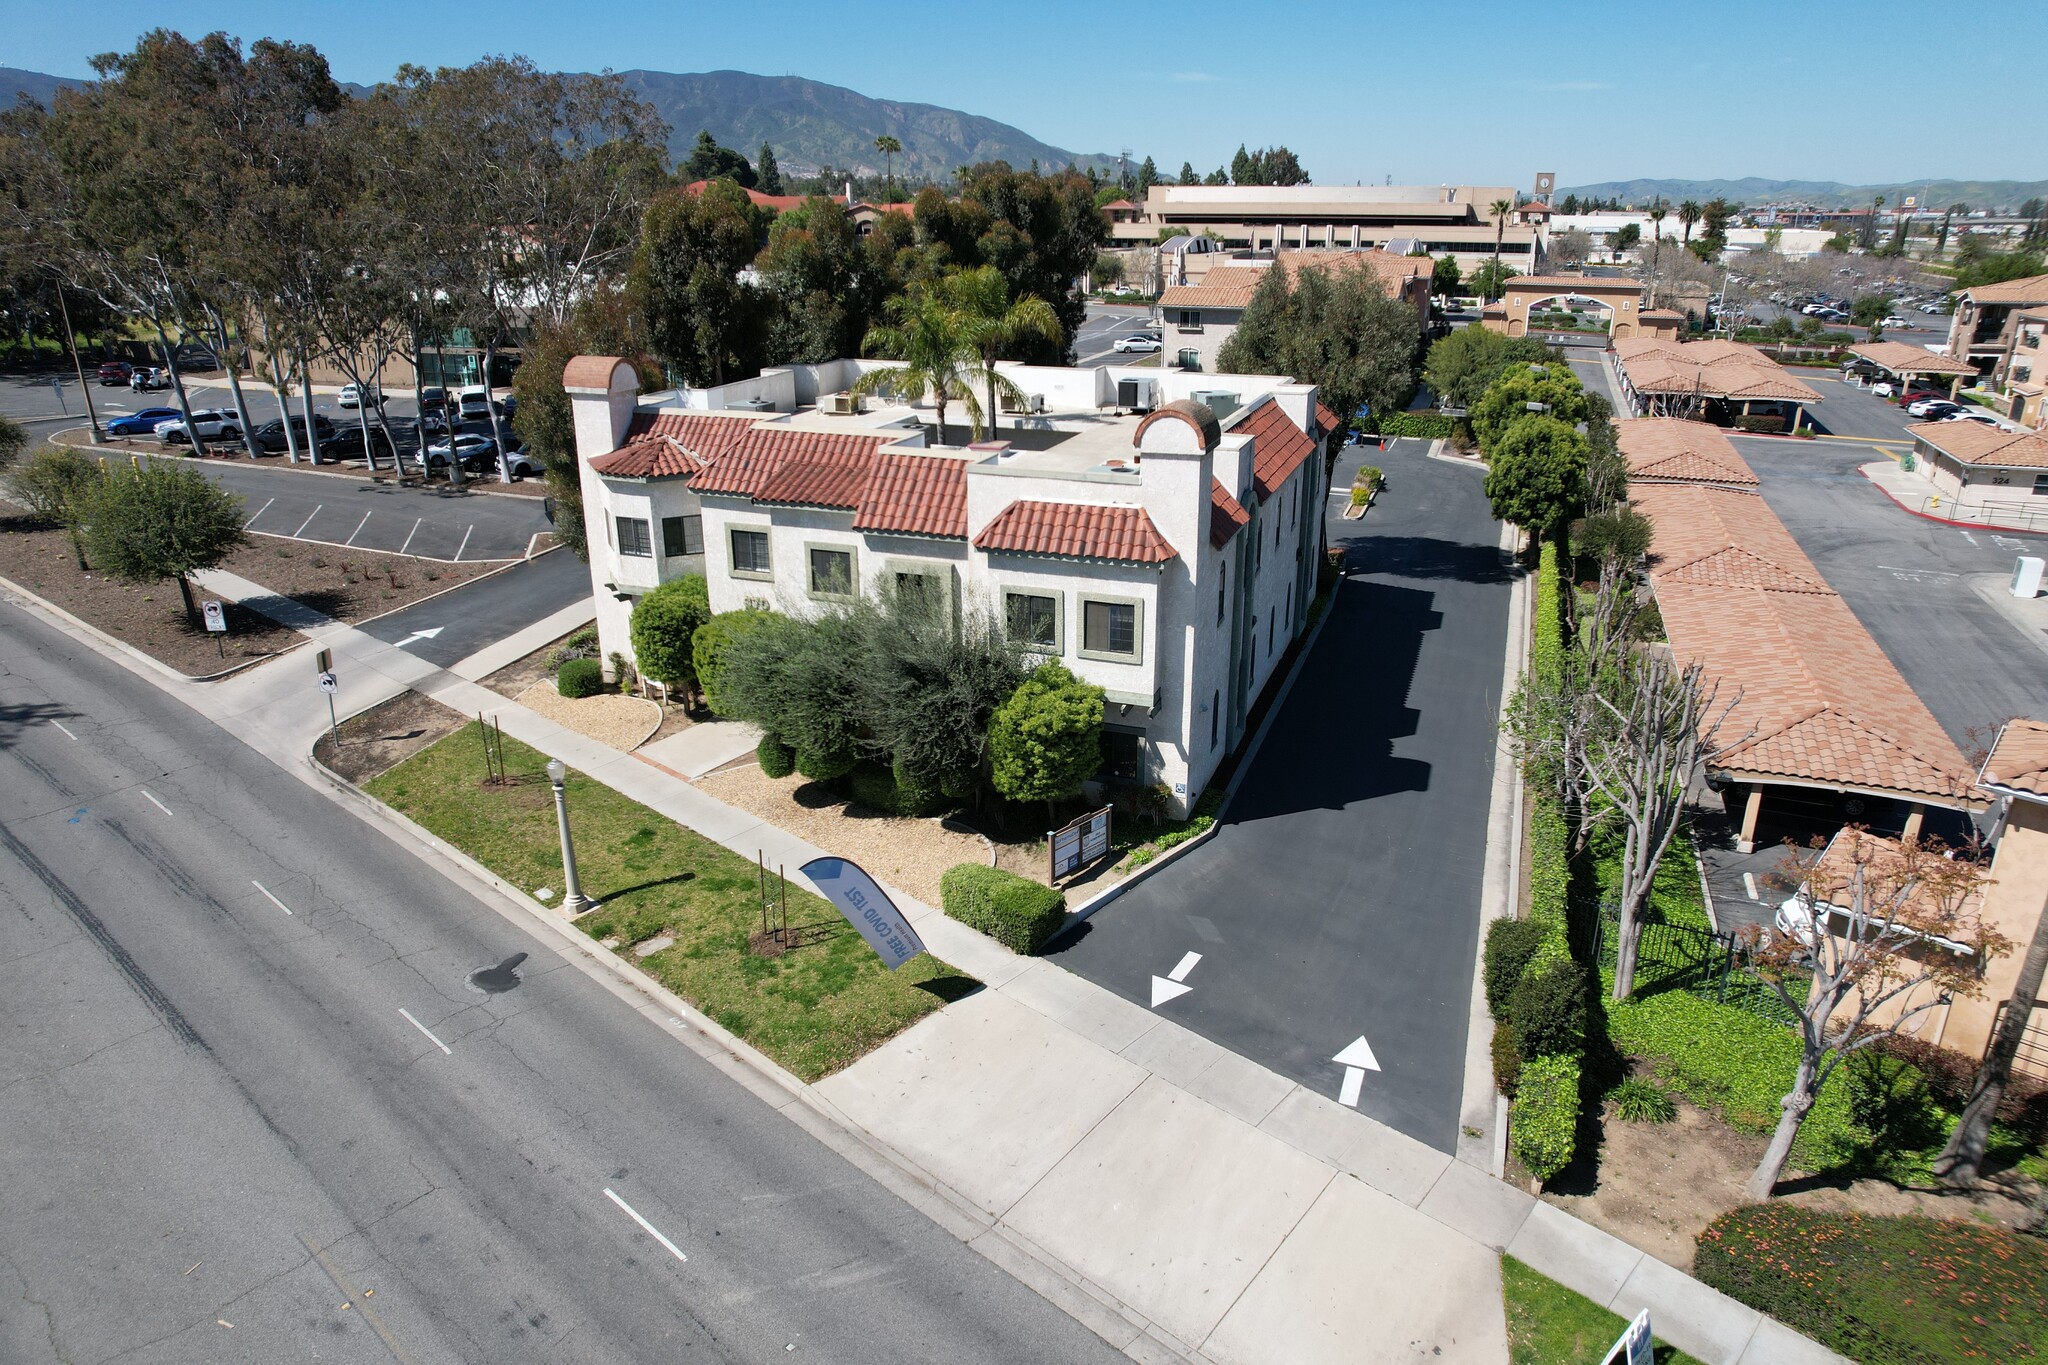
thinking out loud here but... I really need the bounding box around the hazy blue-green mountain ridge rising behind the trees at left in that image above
[0,65,1116,178]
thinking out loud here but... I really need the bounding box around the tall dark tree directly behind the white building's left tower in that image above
[633,180,766,385]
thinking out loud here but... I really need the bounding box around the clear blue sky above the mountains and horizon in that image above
[0,0,2048,188]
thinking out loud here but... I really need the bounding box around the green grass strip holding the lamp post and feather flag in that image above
[367,724,979,1081]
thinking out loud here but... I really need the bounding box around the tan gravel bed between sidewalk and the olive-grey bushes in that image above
[696,759,999,905]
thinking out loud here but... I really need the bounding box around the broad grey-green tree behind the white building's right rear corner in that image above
[1217,266,1421,415]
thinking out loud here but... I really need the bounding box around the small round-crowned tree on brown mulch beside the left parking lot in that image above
[84,460,248,626]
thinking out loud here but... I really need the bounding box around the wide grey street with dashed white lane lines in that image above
[0,606,1122,1365]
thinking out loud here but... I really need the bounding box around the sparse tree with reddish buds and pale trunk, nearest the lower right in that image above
[1743,827,2011,1201]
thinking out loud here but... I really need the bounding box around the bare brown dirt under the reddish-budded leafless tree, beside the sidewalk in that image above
[1542,1099,2032,1273]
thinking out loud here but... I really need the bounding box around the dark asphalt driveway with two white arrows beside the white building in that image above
[1055,442,1509,1152]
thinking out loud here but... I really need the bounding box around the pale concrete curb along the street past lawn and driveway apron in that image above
[305,740,1208,1365]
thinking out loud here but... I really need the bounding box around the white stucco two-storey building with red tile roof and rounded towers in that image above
[563,356,1339,810]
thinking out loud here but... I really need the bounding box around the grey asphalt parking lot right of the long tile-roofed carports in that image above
[1735,435,2048,753]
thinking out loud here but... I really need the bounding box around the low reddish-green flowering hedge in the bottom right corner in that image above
[1692,1201,2048,1365]
